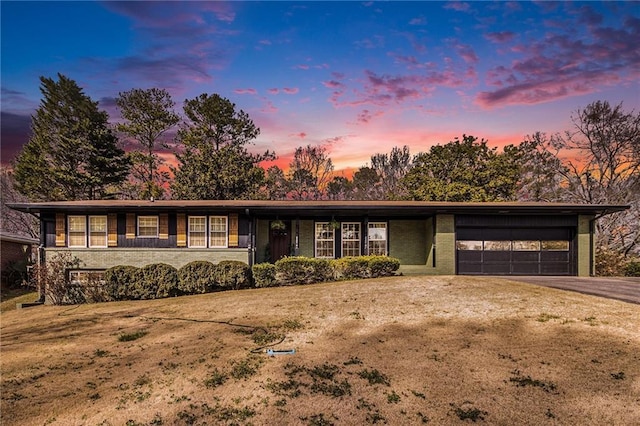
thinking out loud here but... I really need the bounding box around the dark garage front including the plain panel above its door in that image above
[456,215,577,275]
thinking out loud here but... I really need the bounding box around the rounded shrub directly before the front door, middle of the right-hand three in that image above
[275,256,334,285]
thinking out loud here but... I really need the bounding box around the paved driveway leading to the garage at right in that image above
[502,276,640,304]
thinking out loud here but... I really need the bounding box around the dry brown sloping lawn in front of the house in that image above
[0,277,640,425]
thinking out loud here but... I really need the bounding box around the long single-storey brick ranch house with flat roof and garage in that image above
[9,200,628,276]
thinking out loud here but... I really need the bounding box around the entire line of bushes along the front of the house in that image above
[45,256,400,304]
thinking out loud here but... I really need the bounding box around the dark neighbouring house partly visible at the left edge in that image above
[0,232,39,288]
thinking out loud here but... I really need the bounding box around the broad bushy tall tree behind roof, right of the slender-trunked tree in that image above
[171,94,274,200]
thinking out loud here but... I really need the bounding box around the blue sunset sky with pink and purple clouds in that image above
[0,0,640,174]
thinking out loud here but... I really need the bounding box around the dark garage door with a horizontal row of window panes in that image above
[456,228,575,275]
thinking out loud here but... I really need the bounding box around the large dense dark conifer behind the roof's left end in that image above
[15,74,129,201]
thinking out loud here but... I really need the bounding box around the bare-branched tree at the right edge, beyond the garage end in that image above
[554,101,640,256]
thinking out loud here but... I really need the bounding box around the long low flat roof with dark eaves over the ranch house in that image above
[7,200,629,216]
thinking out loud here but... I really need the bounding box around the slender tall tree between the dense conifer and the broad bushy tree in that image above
[116,88,180,199]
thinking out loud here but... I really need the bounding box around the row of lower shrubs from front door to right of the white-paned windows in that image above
[252,256,400,287]
